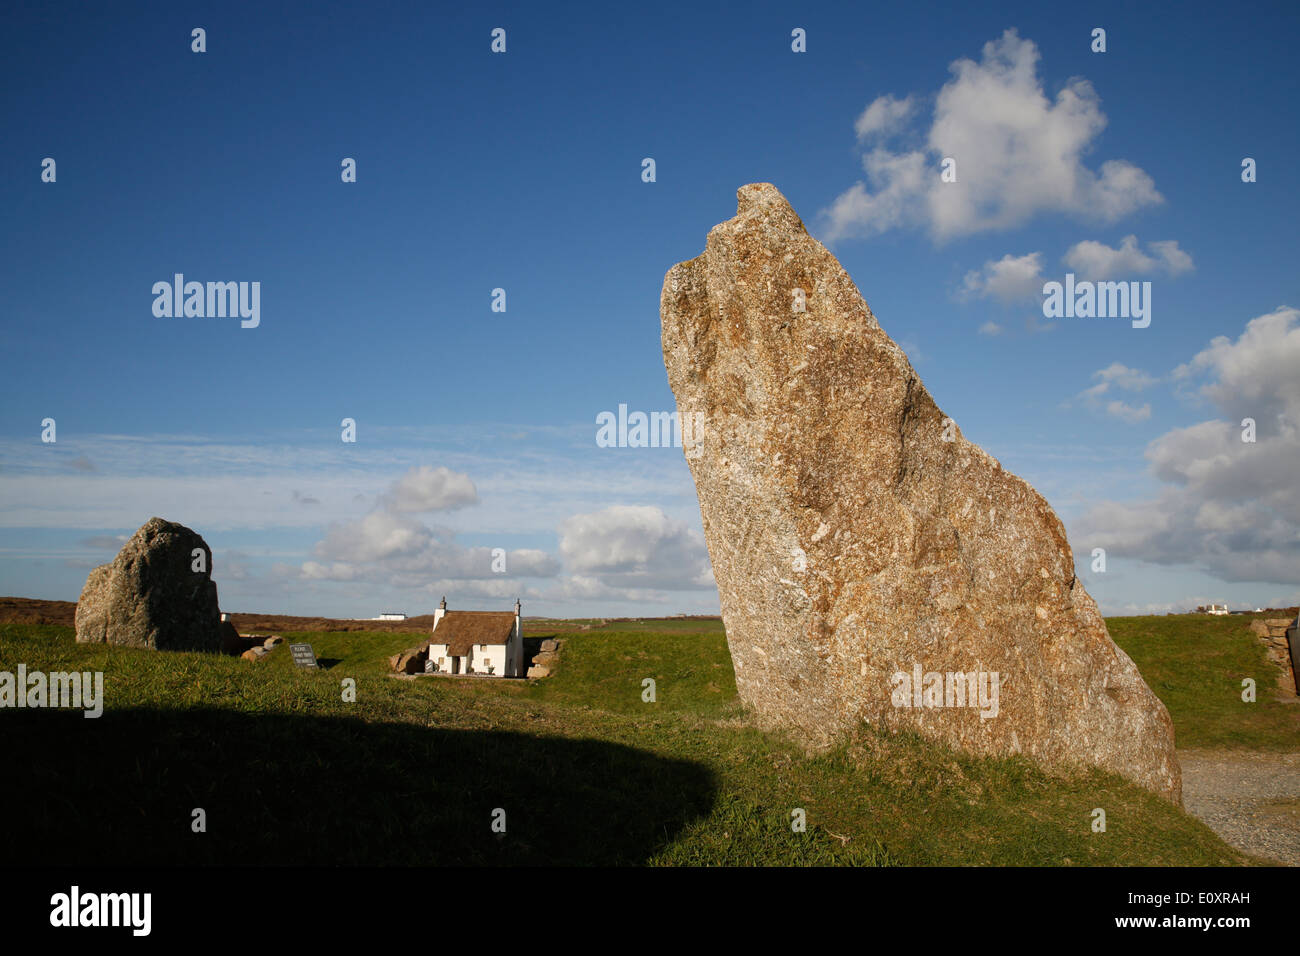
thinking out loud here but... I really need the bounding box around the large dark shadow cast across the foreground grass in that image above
[0,709,716,865]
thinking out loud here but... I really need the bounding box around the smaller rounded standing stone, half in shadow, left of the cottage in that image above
[77,518,229,652]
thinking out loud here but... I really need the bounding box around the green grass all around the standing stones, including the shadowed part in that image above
[0,617,1295,866]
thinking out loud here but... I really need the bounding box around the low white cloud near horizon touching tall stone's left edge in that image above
[560,505,715,591]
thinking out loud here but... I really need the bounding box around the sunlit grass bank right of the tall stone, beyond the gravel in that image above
[1106,614,1300,750]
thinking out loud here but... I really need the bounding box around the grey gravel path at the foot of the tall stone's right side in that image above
[1178,750,1300,866]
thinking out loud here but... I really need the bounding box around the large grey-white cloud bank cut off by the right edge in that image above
[1076,308,1300,585]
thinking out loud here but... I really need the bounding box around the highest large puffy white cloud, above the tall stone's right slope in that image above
[824,30,1164,241]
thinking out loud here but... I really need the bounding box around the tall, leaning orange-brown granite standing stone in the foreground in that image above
[660,183,1180,801]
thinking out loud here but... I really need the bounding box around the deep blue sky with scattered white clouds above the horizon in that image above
[0,3,1300,617]
